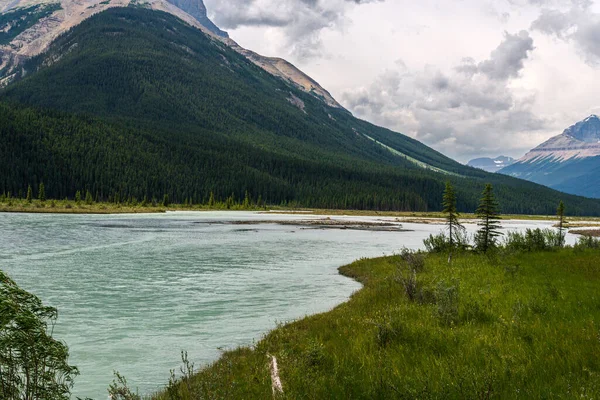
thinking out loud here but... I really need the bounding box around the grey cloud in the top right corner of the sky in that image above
[531,0,600,66]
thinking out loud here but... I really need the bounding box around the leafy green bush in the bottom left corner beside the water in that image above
[0,271,78,400]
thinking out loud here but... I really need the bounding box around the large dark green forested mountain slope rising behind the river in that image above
[0,6,600,215]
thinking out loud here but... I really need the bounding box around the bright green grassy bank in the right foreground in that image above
[152,249,600,400]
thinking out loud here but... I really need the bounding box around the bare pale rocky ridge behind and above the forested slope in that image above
[0,0,342,108]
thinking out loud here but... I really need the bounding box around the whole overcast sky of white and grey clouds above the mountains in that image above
[205,0,600,162]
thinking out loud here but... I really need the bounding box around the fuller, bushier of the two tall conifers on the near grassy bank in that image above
[475,183,502,253]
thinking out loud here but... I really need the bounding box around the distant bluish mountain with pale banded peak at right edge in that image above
[500,115,600,198]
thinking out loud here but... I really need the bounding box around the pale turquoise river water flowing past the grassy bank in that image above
[0,212,575,400]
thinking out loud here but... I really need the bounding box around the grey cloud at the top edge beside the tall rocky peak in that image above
[206,0,383,59]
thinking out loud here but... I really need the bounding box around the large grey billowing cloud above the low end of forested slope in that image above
[342,31,546,161]
